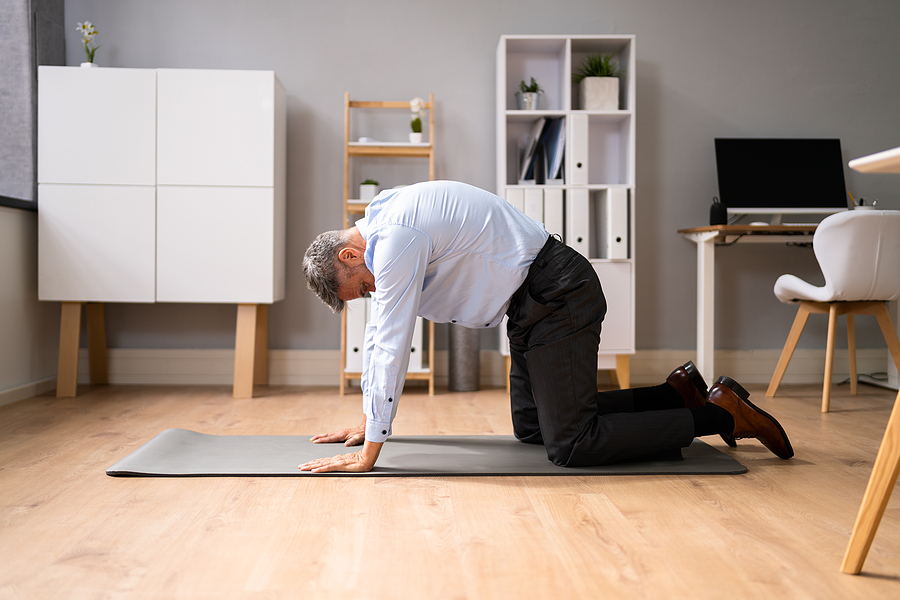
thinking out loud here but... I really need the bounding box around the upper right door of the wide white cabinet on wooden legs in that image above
[158,69,283,186]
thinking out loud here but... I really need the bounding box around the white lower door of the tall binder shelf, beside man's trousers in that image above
[594,262,634,353]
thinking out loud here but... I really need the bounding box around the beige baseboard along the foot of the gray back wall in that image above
[68,348,887,390]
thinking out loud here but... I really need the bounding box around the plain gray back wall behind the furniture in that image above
[65,0,900,349]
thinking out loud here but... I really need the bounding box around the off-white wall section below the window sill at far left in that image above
[0,206,59,404]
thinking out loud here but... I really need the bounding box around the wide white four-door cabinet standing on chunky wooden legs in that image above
[38,66,287,397]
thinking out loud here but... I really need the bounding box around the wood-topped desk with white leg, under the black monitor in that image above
[678,225,816,383]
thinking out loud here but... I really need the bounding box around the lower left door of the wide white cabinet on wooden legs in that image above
[38,183,156,302]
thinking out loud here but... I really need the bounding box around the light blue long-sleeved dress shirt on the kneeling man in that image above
[356,181,548,442]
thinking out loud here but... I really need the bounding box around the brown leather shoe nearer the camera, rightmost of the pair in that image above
[706,377,794,458]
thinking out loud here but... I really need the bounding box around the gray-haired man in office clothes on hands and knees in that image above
[300,181,793,472]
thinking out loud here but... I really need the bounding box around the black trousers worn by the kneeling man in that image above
[507,237,694,467]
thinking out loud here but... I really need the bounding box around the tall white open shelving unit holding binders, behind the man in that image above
[496,35,635,387]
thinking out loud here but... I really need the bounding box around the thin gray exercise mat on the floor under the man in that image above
[106,429,747,477]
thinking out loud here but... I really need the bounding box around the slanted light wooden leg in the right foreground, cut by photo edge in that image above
[841,394,900,575]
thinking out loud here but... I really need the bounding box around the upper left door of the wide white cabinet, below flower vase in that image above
[38,66,156,185]
